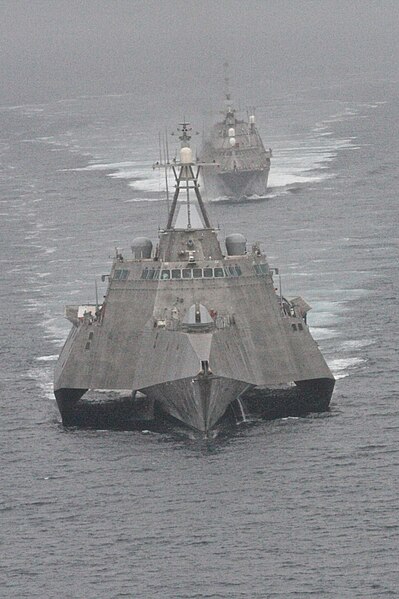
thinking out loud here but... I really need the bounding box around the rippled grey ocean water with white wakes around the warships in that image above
[0,81,399,599]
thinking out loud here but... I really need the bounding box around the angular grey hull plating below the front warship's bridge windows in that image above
[55,247,333,431]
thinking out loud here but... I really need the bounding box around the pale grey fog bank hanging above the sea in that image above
[0,0,399,105]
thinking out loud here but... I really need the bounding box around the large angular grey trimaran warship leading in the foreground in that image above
[54,123,334,435]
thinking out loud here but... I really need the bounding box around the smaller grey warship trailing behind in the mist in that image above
[201,65,272,200]
